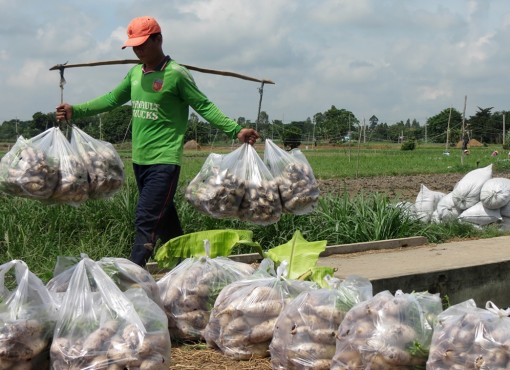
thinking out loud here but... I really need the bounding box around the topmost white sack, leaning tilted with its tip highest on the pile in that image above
[452,164,492,211]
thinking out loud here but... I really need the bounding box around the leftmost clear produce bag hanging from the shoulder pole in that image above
[0,136,58,200]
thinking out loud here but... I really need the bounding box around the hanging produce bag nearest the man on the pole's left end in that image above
[71,125,124,199]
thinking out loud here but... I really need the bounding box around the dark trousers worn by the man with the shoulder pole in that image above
[130,164,183,266]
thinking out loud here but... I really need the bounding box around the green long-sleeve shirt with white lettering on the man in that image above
[73,60,241,165]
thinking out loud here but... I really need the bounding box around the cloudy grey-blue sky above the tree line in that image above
[0,0,510,124]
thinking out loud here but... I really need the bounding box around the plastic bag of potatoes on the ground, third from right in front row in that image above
[269,276,372,370]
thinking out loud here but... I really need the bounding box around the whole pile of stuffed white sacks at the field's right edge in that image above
[398,164,510,228]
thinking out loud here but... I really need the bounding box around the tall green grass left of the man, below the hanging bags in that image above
[0,181,137,279]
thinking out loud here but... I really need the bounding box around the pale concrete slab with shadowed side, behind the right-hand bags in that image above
[318,236,510,308]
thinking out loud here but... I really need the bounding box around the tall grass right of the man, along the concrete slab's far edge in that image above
[176,188,502,253]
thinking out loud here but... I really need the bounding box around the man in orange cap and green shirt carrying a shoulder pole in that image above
[56,16,259,266]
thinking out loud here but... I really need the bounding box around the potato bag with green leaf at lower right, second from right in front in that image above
[331,290,442,370]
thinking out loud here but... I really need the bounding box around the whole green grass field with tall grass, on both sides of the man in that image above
[0,144,510,280]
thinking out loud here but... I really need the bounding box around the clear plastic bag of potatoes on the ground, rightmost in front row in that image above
[427,299,510,370]
